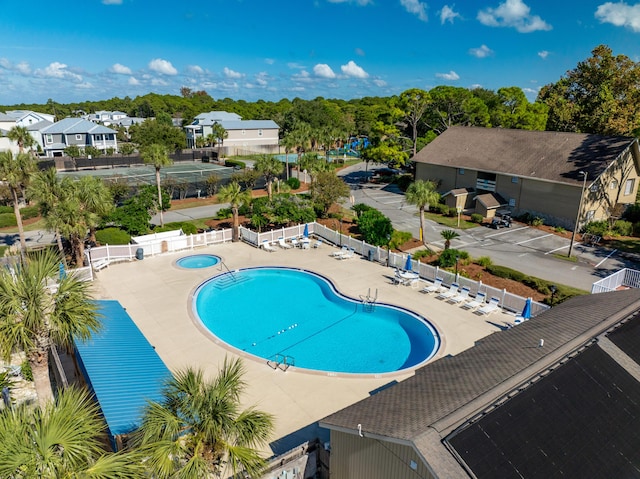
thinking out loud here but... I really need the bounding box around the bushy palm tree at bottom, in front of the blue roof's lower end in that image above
[132,359,273,479]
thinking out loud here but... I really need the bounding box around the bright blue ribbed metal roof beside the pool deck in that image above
[76,301,171,444]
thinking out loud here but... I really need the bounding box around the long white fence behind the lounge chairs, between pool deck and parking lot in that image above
[240,222,549,316]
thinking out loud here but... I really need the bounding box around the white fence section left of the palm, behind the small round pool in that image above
[86,229,231,270]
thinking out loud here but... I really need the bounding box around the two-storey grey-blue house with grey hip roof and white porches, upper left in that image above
[41,118,118,157]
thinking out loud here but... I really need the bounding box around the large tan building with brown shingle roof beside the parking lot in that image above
[414,126,640,229]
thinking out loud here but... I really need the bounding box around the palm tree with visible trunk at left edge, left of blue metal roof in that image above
[0,249,101,404]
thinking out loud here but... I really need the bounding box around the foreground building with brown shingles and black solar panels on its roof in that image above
[320,289,640,479]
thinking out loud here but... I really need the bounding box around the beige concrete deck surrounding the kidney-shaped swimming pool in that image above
[94,243,514,453]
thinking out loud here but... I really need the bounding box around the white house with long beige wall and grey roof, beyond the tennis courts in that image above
[185,111,280,155]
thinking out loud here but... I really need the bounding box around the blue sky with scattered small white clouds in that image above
[0,0,640,104]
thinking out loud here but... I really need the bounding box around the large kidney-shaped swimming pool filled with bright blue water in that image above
[193,268,440,374]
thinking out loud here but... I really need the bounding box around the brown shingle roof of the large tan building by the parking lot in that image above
[414,126,636,184]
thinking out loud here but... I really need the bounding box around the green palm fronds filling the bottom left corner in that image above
[0,388,145,479]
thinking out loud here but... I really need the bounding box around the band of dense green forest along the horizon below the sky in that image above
[0,45,640,163]
